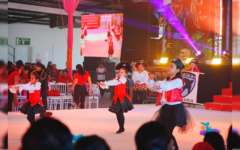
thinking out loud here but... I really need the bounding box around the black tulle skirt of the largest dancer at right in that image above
[153,103,195,133]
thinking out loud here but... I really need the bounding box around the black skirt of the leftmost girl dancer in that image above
[20,102,46,114]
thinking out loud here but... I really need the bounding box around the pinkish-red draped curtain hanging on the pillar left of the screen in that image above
[63,0,79,77]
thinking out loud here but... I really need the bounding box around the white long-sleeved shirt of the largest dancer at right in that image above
[148,79,183,105]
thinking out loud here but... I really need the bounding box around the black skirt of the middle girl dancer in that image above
[109,97,133,113]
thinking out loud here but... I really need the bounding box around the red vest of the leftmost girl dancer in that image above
[23,89,44,106]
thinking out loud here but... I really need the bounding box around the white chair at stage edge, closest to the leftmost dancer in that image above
[48,96,63,110]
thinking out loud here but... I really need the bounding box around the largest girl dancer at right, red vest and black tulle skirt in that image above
[148,59,194,150]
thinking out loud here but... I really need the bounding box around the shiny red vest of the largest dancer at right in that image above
[156,78,184,106]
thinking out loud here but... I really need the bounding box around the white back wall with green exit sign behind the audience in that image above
[8,23,84,69]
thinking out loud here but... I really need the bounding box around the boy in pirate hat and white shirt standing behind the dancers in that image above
[132,60,148,104]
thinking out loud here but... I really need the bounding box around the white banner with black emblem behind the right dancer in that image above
[182,71,203,104]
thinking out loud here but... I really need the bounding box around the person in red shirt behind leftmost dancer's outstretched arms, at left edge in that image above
[8,64,22,111]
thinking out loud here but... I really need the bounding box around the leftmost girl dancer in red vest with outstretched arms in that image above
[9,72,46,124]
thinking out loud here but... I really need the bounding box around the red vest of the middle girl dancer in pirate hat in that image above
[113,83,131,104]
